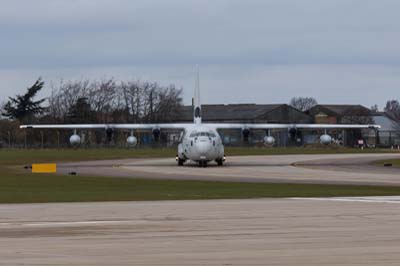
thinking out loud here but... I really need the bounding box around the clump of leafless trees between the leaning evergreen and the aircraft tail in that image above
[40,79,182,128]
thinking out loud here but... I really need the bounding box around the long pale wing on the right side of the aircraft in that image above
[205,123,381,129]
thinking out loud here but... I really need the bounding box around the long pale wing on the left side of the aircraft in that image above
[20,123,193,130]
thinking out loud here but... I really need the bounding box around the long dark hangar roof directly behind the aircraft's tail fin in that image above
[179,104,312,123]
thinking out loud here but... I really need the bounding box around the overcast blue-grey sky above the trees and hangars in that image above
[0,0,400,107]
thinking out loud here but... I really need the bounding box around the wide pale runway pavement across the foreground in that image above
[0,197,400,266]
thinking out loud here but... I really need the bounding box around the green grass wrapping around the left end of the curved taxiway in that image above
[0,148,400,203]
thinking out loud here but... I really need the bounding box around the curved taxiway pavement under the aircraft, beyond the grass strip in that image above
[59,153,400,185]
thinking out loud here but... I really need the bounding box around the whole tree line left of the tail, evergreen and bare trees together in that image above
[0,78,183,146]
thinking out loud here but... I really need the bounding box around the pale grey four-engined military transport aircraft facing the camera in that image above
[20,68,380,167]
